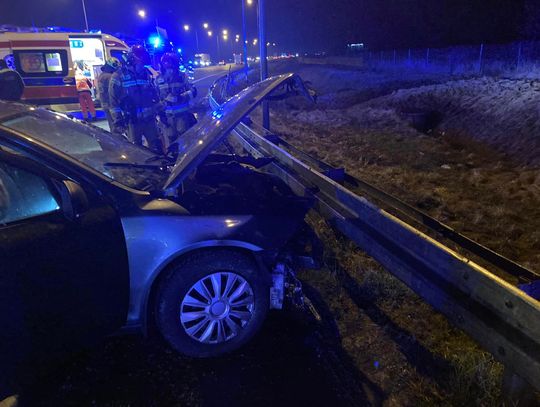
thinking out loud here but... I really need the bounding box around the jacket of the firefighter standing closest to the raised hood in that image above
[156,73,193,115]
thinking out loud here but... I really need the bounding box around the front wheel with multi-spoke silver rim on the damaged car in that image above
[155,250,270,358]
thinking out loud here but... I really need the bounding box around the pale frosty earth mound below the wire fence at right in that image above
[356,77,540,165]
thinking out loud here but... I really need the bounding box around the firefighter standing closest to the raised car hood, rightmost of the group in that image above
[156,53,197,150]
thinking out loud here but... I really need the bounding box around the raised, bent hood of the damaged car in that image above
[164,73,310,194]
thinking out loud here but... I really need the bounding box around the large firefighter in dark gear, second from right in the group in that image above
[109,45,163,154]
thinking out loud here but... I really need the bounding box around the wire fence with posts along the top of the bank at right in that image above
[362,41,540,75]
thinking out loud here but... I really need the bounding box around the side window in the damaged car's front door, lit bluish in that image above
[0,162,60,225]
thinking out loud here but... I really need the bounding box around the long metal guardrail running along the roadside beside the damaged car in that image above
[210,72,540,390]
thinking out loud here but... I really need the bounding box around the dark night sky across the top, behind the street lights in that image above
[0,0,539,52]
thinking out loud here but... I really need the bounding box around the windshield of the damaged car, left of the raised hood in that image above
[2,109,168,190]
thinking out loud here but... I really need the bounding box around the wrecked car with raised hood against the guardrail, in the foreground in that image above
[0,75,318,396]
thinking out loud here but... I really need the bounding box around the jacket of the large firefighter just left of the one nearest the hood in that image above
[109,66,160,127]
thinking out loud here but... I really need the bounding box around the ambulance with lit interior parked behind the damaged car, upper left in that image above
[0,31,129,111]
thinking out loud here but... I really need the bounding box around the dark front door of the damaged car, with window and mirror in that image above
[0,147,129,400]
